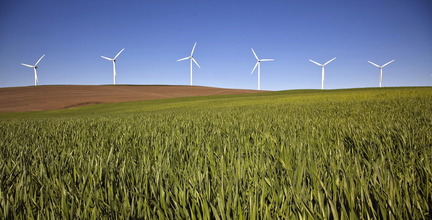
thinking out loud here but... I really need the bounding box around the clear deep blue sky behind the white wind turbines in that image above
[0,0,432,90]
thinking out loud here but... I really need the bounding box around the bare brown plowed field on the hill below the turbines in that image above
[0,85,260,112]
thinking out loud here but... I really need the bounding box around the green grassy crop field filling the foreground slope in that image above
[0,87,432,219]
